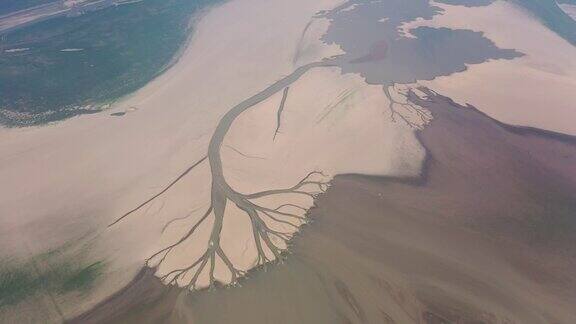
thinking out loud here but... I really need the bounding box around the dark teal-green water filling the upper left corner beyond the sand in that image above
[0,0,216,126]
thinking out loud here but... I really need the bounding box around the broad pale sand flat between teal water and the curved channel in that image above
[0,0,418,318]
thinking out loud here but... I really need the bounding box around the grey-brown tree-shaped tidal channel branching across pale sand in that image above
[109,60,336,290]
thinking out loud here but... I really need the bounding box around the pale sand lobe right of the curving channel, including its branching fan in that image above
[115,22,424,289]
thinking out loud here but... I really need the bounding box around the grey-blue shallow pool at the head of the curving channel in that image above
[324,0,522,86]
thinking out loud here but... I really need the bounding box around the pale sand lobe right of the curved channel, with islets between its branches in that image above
[151,68,424,286]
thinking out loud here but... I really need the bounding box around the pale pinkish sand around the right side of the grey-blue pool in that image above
[403,1,576,134]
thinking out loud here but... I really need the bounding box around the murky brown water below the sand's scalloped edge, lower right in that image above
[77,89,576,323]
